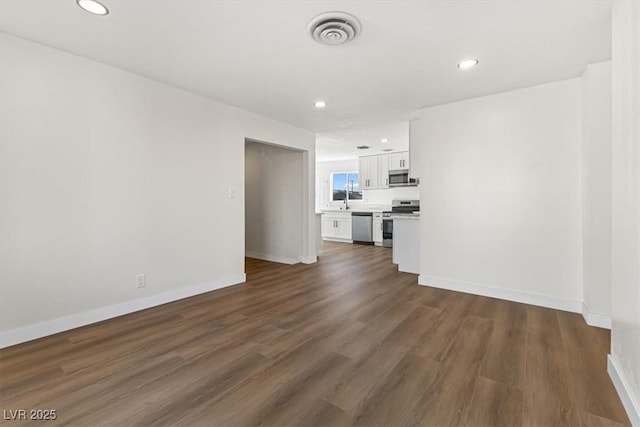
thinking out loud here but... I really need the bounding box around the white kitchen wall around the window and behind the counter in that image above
[316,159,420,210]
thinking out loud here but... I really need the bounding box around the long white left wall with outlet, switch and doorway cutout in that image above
[0,33,315,345]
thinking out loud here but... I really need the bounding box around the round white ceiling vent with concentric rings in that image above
[307,12,362,46]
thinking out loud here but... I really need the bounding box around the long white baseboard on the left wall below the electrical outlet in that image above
[0,274,246,348]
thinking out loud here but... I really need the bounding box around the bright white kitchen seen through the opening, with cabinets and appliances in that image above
[316,122,420,274]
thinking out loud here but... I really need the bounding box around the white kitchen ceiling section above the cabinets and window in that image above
[316,122,409,162]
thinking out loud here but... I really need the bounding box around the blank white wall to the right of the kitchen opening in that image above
[411,79,582,311]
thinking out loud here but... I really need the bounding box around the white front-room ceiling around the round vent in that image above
[0,0,611,131]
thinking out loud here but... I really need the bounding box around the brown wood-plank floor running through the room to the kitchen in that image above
[0,243,629,426]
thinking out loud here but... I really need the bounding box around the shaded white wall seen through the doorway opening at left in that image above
[244,142,303,264]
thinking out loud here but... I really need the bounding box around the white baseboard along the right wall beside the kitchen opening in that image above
[418,275,582,313]
